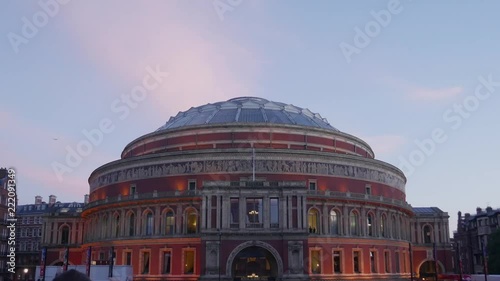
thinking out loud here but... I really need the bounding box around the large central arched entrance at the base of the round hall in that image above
[231,246,278,281]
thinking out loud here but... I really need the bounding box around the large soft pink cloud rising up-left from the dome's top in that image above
[60,1,261,116]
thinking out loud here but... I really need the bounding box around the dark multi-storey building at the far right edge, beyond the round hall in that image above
[453,207,500,274]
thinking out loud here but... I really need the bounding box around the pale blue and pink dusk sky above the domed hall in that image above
[0,0,500,230]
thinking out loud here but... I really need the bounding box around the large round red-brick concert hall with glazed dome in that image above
[82,97,414,280]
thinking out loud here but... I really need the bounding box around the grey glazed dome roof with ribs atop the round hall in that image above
[156,97,339,132]
